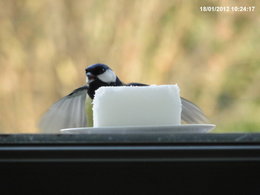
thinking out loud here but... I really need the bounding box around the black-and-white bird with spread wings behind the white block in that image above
[39,63,208,133]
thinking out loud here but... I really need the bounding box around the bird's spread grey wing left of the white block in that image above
[39,86,88,133]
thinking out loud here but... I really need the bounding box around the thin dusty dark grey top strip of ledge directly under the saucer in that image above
[0,133,260,145]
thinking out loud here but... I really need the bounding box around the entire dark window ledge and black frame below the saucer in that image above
[0,133,260,194]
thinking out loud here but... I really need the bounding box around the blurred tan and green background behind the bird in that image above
[0,0,260,133]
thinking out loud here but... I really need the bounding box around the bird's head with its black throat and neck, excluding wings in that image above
[86,64,122,99]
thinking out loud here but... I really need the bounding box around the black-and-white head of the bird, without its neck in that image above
[86,64,117,85]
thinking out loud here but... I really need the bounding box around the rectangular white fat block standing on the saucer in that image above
[93,85,181,127]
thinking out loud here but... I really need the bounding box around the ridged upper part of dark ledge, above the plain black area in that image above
[0,133,260,163]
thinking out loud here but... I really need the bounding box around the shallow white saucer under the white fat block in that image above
[60,124,216,134]
